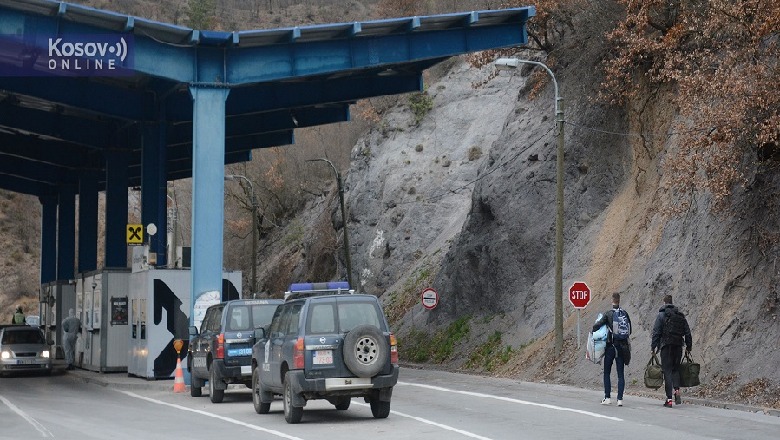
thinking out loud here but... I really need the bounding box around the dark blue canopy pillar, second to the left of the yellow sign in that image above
[77,174,98,273]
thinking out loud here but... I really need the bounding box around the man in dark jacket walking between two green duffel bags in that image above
[650,295,692,408]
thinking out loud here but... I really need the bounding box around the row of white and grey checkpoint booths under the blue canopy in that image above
[39,251,242,379]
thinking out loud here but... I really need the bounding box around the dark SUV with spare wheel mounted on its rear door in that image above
[252,282,399,423]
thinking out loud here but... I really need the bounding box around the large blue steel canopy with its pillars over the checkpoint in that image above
[0,0,535,310]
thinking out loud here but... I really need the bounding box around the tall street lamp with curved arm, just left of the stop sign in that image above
[495,58,563,355]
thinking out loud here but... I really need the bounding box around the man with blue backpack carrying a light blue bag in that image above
[593,293,631,406]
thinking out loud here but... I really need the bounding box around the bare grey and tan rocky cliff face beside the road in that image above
[338,37,780,407]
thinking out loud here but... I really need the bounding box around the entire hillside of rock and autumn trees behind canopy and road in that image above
[0,0,780,408]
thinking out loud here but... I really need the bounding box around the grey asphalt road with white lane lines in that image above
[0,369,780,440]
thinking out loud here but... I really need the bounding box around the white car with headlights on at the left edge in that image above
[0,325,52,376]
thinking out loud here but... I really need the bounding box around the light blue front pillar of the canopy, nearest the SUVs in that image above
[190,85,229,324]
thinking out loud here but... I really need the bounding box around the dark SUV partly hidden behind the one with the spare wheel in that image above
[187,299,284,403]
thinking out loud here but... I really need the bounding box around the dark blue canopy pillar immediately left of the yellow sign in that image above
[105,151,129,268]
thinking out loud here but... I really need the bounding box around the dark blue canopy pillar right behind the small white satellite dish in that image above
[141,122,168,266]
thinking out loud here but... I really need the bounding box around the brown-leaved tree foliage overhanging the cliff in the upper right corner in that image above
[603,0,780,212]
